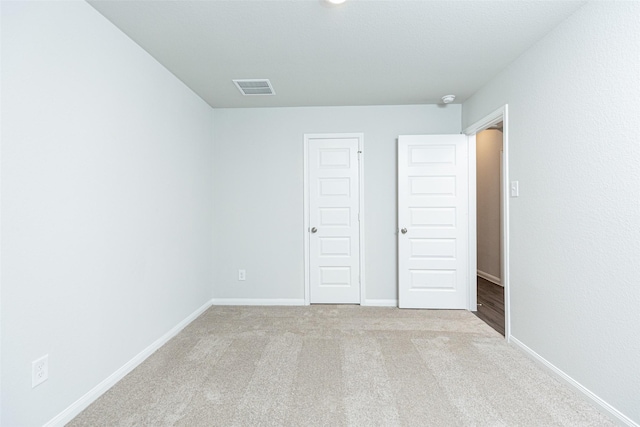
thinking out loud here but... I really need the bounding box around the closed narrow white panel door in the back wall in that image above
[308,137,360,304]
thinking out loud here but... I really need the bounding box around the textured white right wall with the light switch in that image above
[463,2,640,423]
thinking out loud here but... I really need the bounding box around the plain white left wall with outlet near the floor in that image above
[1,1,213,426]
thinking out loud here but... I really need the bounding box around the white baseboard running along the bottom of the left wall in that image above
[43,301,211,427]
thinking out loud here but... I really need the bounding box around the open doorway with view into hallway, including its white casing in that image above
[465,105,511,340]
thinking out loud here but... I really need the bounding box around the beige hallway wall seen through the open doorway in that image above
[476,129,502,279]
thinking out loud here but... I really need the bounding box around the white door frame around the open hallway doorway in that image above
[464,104,511,342]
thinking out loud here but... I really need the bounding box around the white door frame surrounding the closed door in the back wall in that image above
[303,133,366,305]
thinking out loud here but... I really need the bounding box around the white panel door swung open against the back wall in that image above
[398,135,469,309]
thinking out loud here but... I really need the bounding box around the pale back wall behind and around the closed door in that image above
[214,105,461,300]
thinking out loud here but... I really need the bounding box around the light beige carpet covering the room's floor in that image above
[69,305,613,427]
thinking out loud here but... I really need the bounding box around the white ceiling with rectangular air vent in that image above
[89,0,584,107]
